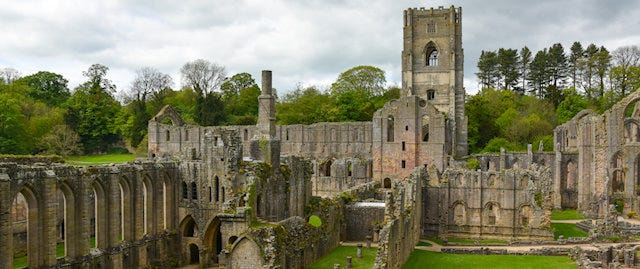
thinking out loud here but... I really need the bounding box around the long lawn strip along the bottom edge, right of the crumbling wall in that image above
[402,249,577,269]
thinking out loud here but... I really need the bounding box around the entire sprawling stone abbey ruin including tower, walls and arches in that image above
[0,4,640,268]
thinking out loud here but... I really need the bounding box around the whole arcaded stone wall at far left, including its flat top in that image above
[0,156,179,268]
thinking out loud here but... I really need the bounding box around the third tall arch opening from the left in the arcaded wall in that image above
[91,180,109,249]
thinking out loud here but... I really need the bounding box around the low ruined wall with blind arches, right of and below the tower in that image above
[423,165,553,239]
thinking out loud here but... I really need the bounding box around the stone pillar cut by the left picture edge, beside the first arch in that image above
[0,173,13,268]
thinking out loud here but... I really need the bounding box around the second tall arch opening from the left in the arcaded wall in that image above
[58,181,82,257]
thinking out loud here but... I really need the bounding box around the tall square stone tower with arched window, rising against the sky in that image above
[402,6,467,156]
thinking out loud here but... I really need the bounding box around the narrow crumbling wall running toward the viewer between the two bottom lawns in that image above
[374,168,427,268]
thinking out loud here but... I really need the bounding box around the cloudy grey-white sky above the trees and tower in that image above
[0,0,640,94]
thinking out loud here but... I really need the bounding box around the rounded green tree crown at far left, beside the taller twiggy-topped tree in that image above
[15,71,71,106]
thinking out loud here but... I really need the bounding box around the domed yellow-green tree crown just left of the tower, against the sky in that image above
[331,65,387,97]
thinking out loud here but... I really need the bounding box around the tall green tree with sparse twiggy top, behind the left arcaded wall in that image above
[65,64,120,153]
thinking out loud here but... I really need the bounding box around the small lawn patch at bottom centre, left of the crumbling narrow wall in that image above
[309,246,378,269]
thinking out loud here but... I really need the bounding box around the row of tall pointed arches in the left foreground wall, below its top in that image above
[0,170,176,267]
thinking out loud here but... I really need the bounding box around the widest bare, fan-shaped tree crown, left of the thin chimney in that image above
[180,59,227,97]
